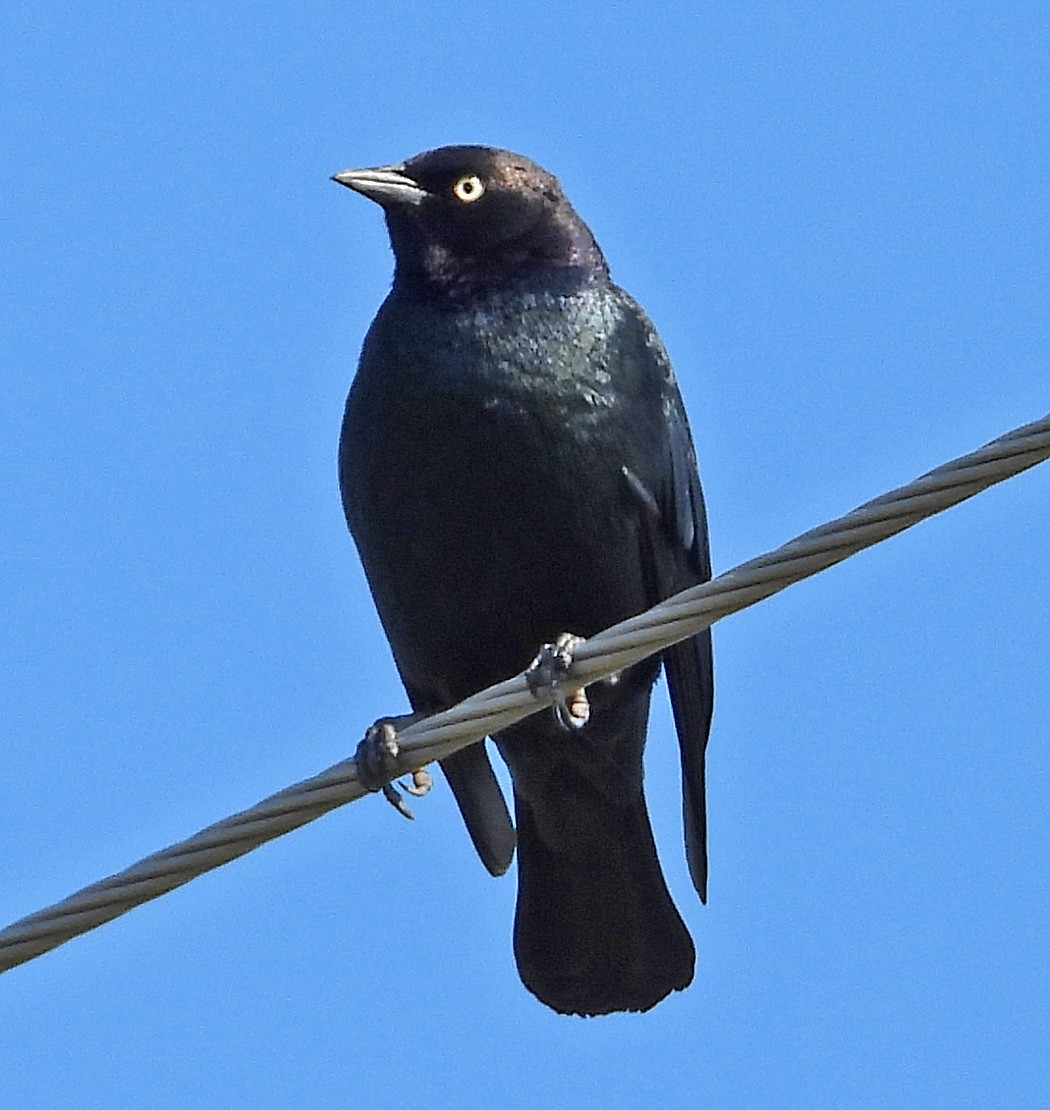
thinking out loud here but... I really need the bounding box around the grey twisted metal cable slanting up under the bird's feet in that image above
[0,414,1050,972]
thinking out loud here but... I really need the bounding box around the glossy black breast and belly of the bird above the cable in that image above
[341,284,658,696]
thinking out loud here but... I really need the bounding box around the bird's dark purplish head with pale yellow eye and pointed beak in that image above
[332,147,606,294]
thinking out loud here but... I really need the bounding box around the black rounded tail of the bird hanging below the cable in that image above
[514,784,694,1016]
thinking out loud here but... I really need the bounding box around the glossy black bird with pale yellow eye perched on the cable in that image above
[333,145,714,1017]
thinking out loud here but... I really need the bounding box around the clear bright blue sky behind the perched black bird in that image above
[0,0,1050,1107]
